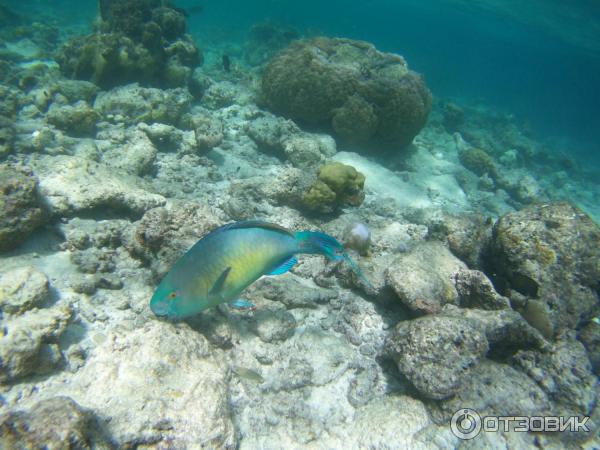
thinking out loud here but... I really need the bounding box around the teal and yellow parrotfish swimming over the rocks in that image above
[150,220,368,320]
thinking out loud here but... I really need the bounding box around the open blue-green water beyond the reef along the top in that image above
[5,0,600,162]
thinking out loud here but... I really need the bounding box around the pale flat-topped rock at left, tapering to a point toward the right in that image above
[36,156,165,217]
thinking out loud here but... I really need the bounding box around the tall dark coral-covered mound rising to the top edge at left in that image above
[56,0,202,88]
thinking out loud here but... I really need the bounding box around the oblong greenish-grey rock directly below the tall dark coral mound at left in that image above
[94,84,192,126]
